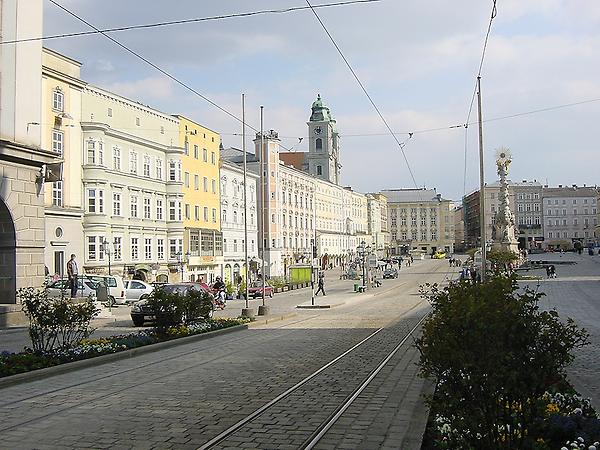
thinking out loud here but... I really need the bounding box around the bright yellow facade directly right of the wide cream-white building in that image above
[176,116,223,283]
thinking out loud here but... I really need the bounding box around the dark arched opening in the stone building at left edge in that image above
[0,199,17,303]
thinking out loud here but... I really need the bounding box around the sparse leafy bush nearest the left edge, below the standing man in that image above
[17,287,100,353]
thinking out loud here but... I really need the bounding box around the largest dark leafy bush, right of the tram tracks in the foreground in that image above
[416,277,587,449]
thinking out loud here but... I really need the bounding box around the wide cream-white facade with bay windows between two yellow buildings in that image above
[81,86,184,281]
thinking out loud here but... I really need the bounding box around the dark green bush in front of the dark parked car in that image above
[148,289,213,334]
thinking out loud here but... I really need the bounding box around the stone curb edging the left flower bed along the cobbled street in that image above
[0,324,249,390]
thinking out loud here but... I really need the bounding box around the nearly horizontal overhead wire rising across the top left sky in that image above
[0,0,383,45]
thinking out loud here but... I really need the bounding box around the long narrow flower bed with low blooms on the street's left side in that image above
[0,318,250,377]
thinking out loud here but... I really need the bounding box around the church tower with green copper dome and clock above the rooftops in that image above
[307,94,342,185]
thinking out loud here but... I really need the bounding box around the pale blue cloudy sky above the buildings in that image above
[44,0,600,200]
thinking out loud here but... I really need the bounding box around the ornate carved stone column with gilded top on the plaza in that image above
[493,148,518,252]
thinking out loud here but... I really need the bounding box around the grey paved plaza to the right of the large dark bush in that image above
[526,253,600,410]
